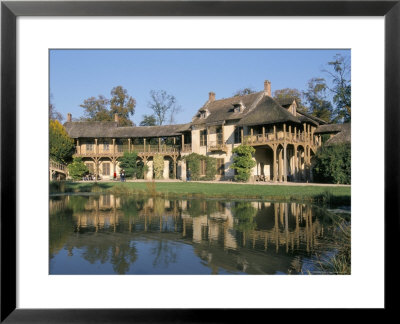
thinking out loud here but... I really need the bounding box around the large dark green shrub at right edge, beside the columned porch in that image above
[313,144,351,184]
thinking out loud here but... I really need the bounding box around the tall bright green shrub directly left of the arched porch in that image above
[230,145,256,182]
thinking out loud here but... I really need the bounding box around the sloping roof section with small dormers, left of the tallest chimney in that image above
[192,91,265,125]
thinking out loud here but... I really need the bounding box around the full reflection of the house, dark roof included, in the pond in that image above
[50,195,330,273]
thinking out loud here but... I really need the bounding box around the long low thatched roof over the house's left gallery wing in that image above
[64,122,190,138]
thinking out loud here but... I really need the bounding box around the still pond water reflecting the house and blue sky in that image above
[49,194,350,274]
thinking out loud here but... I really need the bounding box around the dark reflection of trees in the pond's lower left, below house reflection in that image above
[65,233,137,274]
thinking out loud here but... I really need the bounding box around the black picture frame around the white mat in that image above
[1,0,400,323]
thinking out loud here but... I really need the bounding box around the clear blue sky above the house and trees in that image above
[50,49,350,124]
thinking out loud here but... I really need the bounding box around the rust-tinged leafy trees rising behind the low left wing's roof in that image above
[80,86,136,126]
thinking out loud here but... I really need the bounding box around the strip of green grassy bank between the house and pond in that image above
[50,182,351,206]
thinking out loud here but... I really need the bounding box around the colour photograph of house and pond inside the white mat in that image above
[48,48,352,275]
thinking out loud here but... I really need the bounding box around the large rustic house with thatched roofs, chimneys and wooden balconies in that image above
[64,81,350,182]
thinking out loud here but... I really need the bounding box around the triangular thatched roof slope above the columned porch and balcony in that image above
[238,96,301,126]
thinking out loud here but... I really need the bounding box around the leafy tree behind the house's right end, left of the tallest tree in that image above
[303,78,333,122]
